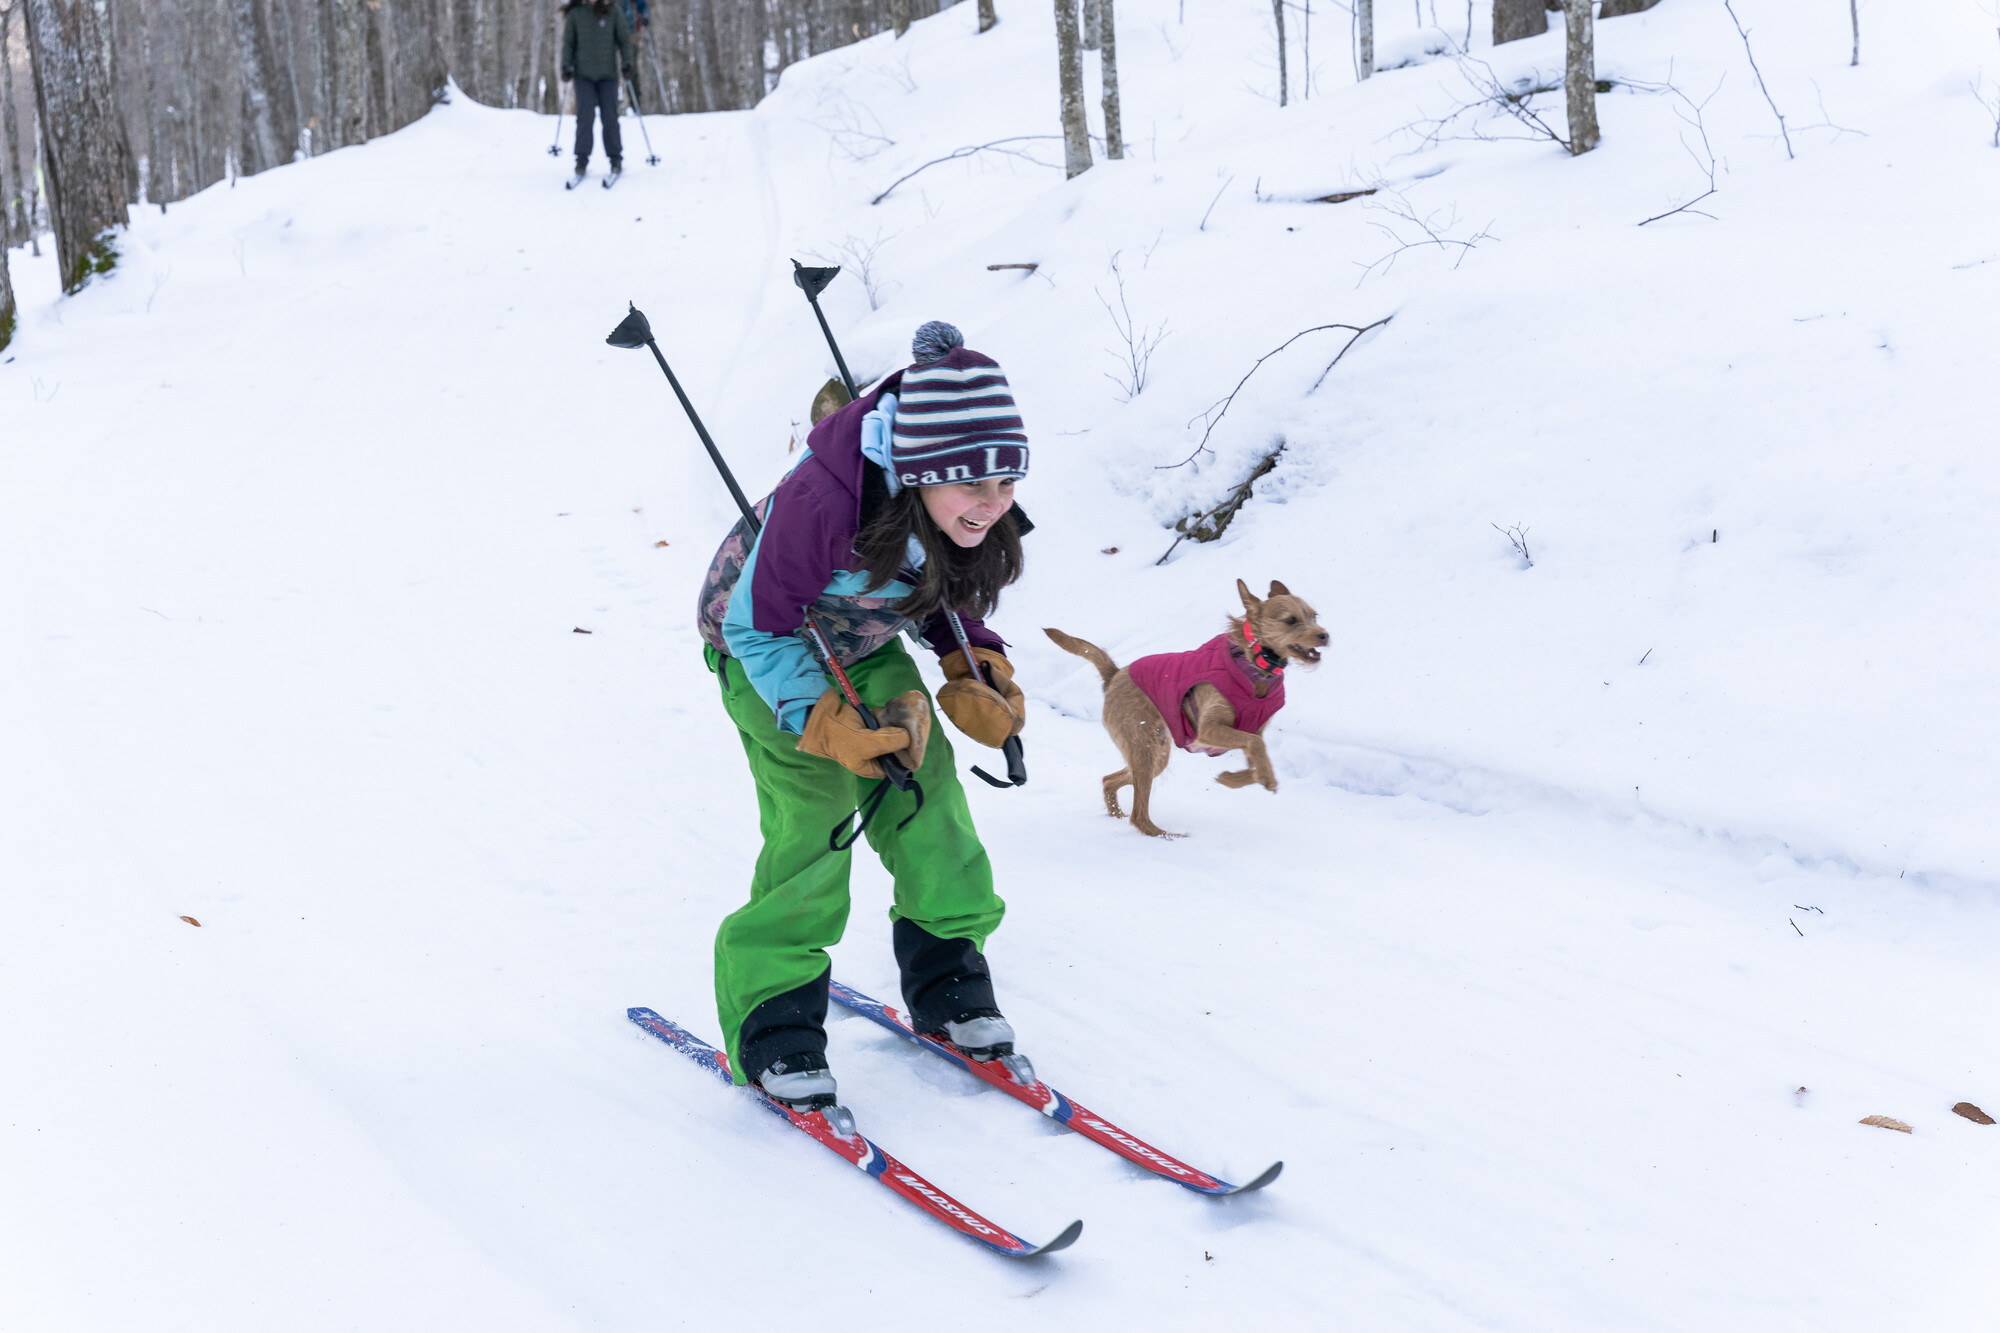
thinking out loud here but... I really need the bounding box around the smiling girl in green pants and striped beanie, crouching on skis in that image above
[698,320,1030,1111]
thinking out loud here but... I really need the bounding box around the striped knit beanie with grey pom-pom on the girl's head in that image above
[890,320,1028,486]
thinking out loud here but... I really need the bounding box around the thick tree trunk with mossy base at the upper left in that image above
[26,0,132,292]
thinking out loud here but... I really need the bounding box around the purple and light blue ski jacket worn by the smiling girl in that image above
[696,370,1006,735]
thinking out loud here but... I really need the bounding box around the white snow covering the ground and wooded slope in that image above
[0,0,2000,1333]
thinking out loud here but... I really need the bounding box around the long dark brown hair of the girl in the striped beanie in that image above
[854,462,1022,620]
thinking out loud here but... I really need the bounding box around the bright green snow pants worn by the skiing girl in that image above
[702,640,1006,1083]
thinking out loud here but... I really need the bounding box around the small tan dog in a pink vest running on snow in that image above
[1042,578,1328,839]
